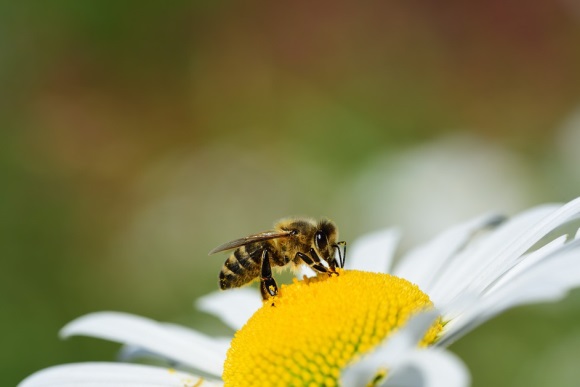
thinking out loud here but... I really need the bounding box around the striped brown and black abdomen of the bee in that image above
[219,246,262,290]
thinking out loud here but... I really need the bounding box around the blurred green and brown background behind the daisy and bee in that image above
[0,0,580,386]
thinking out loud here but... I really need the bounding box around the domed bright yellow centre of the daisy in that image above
[223,270,443,387]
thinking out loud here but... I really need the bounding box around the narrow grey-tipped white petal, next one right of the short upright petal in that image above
[393,215,503,294]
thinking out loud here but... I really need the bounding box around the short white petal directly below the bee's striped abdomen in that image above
[196,288,262,330]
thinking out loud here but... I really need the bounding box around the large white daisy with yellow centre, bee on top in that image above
[20,199,580,387]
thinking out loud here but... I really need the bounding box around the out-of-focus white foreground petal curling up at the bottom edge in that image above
[382,348,470,387]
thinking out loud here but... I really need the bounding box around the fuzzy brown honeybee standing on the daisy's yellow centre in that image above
[209,218,346,300]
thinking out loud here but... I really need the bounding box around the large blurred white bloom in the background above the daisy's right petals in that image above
[335,135,535,246]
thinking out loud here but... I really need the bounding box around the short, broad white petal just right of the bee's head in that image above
[344,229,401,273]
